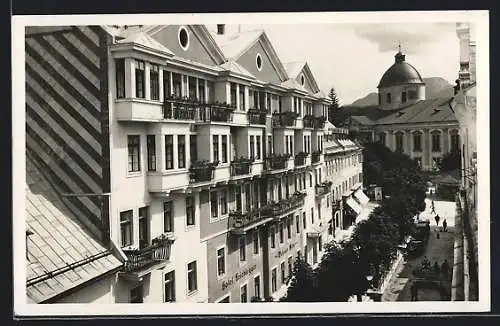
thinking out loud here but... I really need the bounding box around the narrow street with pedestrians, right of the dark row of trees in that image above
[382,199,455,301]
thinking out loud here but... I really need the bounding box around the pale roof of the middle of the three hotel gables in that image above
[212,30,288,81]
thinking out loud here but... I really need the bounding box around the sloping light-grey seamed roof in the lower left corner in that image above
[26,157,122,303]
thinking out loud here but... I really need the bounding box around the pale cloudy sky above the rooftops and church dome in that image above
[211,23,459,104]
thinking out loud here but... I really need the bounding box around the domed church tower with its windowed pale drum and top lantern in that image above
[377,47,425,110]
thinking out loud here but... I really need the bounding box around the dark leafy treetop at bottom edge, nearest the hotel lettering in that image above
[282,255,317,302]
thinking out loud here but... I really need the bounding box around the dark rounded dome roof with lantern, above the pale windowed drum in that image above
[378,52,424,88]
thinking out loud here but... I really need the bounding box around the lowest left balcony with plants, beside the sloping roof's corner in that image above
[123,236,174,273]
